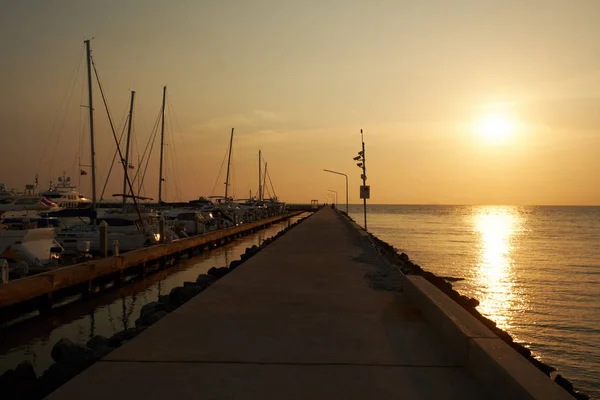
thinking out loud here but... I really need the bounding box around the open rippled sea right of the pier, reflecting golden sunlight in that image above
[349,205,600,398]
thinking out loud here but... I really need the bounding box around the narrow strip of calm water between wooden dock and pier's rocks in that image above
[0,214,308,376]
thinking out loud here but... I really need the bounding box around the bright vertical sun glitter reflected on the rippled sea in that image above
[473,207,521,329]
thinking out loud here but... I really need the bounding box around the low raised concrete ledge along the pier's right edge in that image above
[340,212,576,400]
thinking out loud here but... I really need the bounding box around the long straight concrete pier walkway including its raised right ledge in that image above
[43,208,571,400]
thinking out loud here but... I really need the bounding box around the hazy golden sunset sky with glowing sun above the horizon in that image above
[0,0,600,205]
